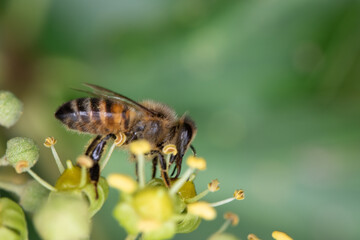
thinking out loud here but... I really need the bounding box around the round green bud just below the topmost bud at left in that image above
[5,137,39,173]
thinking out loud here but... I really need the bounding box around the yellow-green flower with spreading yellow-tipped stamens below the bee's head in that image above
[107,140,244,240]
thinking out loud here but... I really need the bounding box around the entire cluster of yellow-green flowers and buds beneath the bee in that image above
[0,91,292,240]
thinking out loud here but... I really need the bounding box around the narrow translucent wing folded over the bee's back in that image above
[80,83,158,116]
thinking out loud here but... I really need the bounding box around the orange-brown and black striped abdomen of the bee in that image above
[55,98,133,135]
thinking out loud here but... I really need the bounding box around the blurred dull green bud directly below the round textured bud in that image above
[19,180,49,212]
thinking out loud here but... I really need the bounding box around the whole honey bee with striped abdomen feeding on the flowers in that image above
[55,84,197,187]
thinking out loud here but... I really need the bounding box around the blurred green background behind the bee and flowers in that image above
[0,0,360,239]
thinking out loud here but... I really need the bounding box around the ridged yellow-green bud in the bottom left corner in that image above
[0,198,28,240]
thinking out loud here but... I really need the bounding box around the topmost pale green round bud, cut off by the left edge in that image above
[0,91,23,128]
